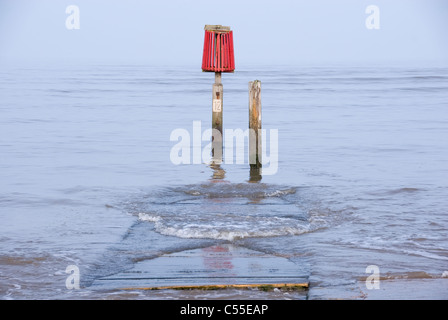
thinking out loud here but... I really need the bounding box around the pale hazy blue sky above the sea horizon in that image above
[0,0,448,67]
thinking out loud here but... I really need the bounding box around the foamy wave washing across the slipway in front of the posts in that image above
[130,183,340,241]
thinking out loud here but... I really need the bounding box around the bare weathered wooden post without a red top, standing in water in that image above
[249,80,262,181]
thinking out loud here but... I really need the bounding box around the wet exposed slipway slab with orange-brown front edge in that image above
[91,244,308,290]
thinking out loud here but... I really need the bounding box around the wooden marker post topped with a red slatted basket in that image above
[202,25,235,162]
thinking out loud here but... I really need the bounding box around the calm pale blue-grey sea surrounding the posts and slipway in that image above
[0,65,448,299]
